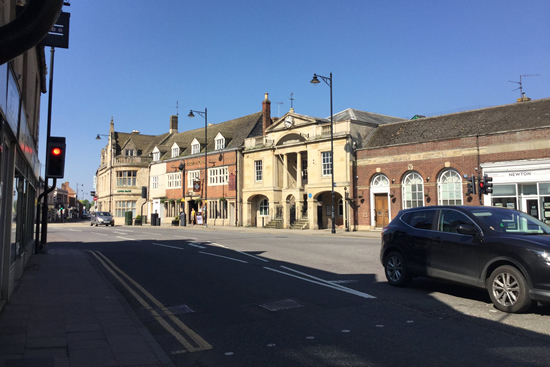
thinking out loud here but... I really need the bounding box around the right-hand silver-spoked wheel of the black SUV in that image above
[487,265,533,313]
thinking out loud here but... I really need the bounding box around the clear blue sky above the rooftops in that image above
[39,0,550,199]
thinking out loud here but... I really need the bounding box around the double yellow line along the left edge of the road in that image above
[88,251,212,353]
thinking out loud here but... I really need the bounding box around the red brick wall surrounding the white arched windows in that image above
[356,129,550,227]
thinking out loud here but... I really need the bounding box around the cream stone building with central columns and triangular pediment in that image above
[242,95,402,229]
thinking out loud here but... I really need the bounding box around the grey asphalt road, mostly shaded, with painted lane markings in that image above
[48,224,550,366]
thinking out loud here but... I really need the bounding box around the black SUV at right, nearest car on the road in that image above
[380,206,550,312]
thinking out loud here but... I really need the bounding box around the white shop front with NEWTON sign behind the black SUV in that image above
[481,160,550,224]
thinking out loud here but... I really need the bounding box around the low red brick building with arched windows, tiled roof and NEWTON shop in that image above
[353,98,550,230]
